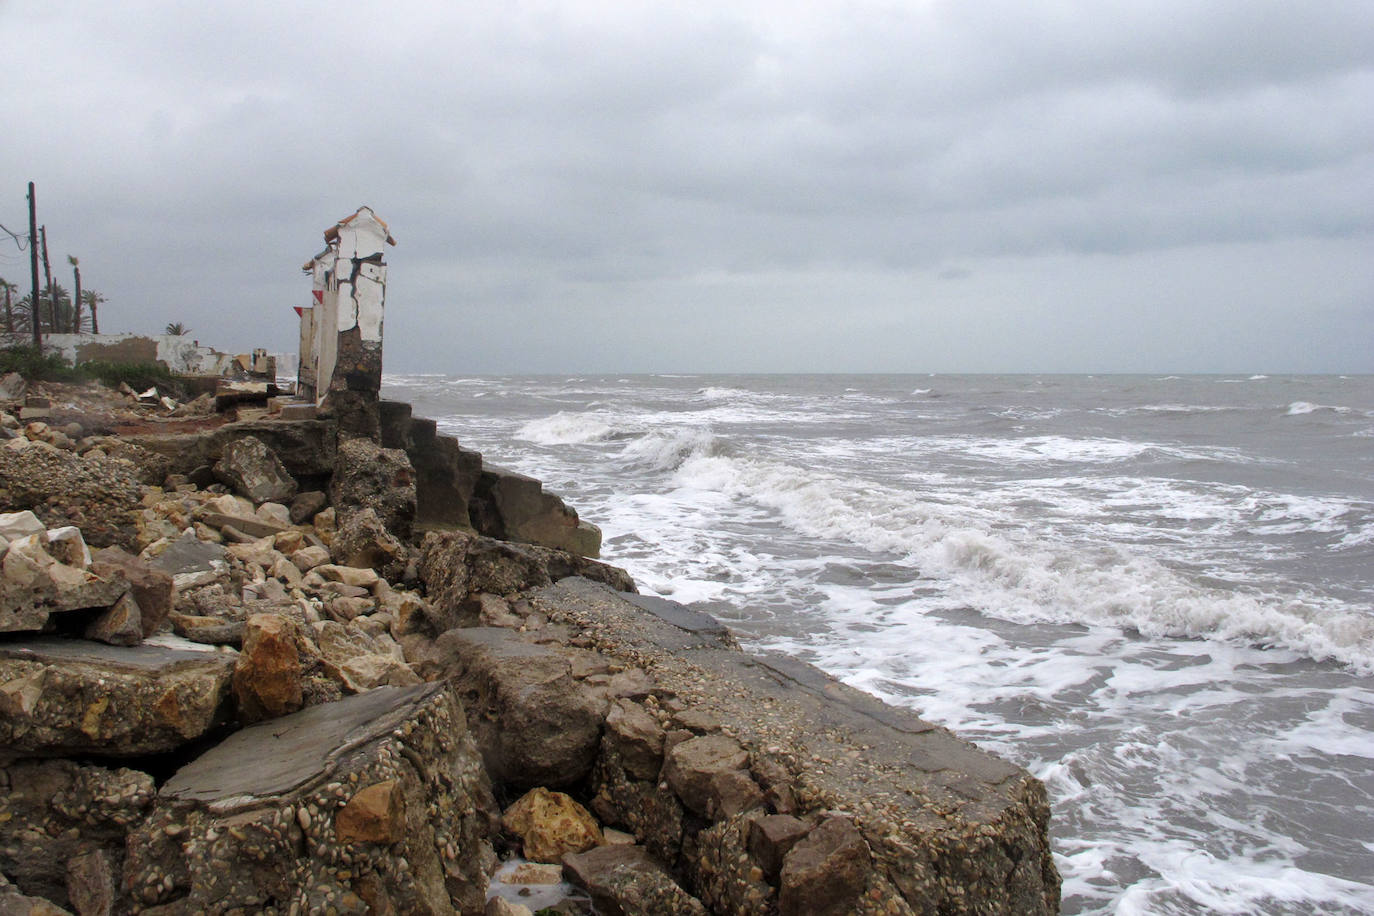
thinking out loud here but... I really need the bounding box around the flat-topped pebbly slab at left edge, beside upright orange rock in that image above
[0,639,234,758]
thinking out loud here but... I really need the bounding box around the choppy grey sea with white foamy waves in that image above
[383,375,1374,915]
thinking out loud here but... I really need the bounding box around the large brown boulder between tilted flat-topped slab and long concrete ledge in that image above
[436,628,606,788]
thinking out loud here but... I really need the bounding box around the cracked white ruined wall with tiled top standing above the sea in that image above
[297,207,396,405]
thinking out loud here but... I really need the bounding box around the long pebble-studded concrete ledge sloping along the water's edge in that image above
[530,578,1059,913]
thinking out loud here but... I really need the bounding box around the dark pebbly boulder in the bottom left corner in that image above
[0,759,157,913]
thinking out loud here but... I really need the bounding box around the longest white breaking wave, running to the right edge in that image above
[660,439,1374,672]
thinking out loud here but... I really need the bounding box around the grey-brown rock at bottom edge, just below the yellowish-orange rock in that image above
[563,846,706,916]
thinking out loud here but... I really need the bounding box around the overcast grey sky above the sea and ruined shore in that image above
[0,0,1374,374]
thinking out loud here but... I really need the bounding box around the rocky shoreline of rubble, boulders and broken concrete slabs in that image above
[0,380,1059,916]
